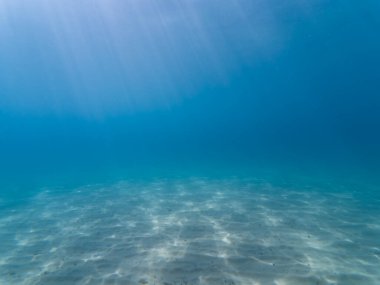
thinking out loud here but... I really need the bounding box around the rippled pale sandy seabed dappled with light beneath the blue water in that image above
[0,178,380,285]
